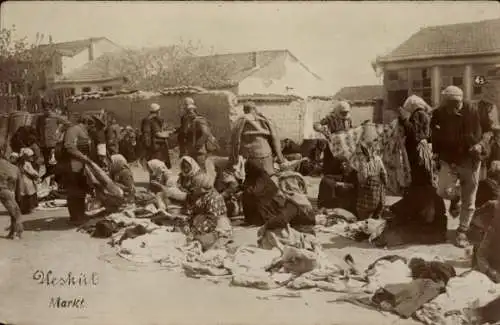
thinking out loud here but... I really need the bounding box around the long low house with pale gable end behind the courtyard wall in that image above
[65,46,321,97]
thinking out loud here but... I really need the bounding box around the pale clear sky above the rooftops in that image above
[0,1,500,94]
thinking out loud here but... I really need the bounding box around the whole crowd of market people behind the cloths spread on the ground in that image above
[0,86,500,280]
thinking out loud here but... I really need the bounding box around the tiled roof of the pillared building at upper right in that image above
[380,19,500,63]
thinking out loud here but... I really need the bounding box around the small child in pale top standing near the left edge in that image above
[17,148,40,214]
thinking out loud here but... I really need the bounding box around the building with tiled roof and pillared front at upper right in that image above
[377,19,500,113]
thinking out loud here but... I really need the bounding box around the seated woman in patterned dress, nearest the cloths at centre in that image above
[184,172,232,250]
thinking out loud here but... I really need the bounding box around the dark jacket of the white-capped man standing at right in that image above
[431,101,498,163]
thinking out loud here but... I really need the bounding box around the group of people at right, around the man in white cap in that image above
[314,86,500,251]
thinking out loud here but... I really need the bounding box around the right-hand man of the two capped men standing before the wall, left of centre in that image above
[178,97,218,178]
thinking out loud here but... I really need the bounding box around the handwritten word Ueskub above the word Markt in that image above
[33,270,99,287]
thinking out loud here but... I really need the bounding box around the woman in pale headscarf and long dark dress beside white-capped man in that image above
[376,95,447,246]
